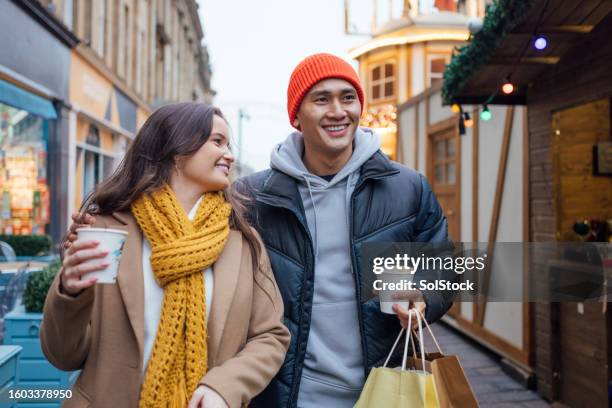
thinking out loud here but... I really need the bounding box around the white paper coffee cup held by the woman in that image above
[76,227,127,283]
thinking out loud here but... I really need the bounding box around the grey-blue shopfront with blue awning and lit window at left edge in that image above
[0,1,78,242]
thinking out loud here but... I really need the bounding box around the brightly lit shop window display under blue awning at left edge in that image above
[0,103,50,235]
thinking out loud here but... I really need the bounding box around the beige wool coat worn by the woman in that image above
[40,212,289,408]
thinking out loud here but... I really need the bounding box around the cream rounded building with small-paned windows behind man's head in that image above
[349,0,485,159]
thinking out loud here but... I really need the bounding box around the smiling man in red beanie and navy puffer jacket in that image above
[237,54,452,408]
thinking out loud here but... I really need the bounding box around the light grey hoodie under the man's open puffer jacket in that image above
[270,128,380,408]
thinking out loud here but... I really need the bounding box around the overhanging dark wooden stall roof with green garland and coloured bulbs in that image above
[442,0,612,105]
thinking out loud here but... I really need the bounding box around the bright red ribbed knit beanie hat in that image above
[287,54,363,126]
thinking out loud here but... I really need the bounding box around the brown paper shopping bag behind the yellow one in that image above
[408,314,478,408]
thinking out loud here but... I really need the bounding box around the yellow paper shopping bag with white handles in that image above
[354,315,440,408]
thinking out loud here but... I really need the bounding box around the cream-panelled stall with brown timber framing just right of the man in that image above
[398,86,533,380]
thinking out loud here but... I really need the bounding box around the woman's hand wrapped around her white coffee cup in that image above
[60,241,109,296]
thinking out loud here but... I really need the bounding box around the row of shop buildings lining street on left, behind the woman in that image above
[0,0,214,247]
